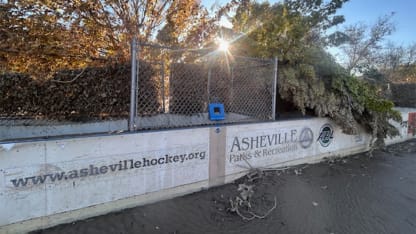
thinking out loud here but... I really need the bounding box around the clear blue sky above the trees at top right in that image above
[202,0,416,46]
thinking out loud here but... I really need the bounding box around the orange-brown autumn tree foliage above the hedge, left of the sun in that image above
[0,0,213,76]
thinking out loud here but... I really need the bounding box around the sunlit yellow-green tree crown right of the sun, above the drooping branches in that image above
[233,0,347,62]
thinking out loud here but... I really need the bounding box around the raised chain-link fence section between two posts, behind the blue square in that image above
[131,45,277,130]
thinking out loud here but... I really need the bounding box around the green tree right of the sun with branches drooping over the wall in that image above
[226,0,400,143]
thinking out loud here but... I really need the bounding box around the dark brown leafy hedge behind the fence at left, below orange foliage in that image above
[0,62,161,121]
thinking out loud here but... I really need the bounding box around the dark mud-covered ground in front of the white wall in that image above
[35,140,416,234]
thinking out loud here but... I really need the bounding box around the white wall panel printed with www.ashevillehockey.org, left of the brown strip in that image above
[0,128,209,229]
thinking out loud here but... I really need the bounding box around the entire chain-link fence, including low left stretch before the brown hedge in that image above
[0,40,277,141]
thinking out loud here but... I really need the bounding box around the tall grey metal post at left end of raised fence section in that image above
[129,38,137,132]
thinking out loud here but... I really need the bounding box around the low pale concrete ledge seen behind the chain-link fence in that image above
[0,113,259,142]
